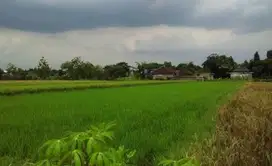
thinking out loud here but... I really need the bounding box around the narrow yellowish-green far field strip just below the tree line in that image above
[0,80,184,95]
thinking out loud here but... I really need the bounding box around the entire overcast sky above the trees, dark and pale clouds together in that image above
[0,0,272,68]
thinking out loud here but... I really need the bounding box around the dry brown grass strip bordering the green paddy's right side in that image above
[192,83,272,166]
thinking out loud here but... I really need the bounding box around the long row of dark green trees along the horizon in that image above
[0,50,272,80]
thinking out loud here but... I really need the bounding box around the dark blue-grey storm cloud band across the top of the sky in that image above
[0,0,272,32]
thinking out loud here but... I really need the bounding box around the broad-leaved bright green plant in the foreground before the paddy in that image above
[25,123,136,166]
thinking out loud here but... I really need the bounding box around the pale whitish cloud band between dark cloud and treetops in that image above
[0,26,272,68]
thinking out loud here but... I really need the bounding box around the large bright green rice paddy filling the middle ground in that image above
[0,81,244,165]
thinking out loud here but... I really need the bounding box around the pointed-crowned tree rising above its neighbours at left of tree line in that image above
[37,57,51,79]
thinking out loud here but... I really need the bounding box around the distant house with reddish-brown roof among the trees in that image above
[151,67,180,80]
